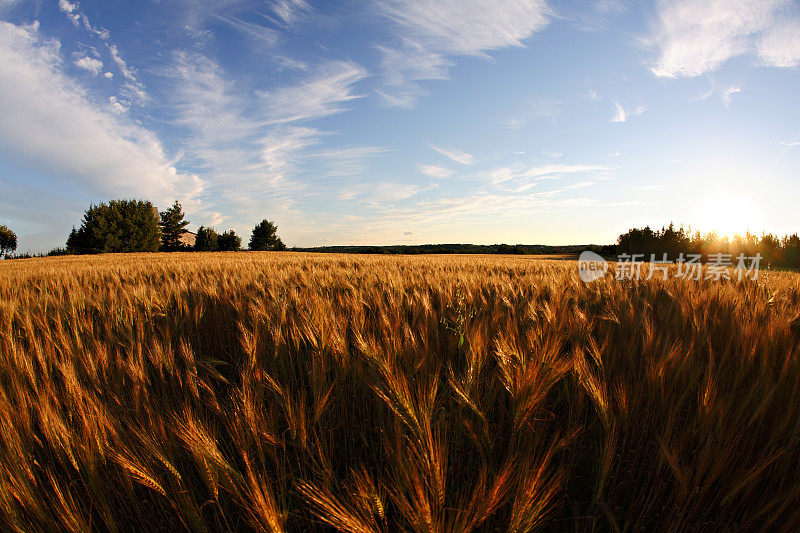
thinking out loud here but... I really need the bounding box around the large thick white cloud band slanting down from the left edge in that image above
[0,22,202,206]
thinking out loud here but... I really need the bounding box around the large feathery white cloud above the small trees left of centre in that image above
[164,48,383,225]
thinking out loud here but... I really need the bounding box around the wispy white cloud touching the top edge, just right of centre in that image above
[378,0,550,107]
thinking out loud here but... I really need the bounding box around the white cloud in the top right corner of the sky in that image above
[650,0,800,78]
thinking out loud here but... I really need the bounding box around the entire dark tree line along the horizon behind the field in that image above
[0,207,800,269]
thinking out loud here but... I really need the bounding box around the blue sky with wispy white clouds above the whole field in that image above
[0,0,800,251]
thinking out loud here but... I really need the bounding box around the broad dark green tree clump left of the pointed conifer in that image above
[67,200,161,254]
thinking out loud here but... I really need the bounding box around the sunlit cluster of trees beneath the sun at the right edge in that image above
[615,224,800,268]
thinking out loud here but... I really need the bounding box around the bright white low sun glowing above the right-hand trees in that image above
[693,189,761,238]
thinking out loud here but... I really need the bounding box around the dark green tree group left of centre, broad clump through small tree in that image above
[64,200,286,254]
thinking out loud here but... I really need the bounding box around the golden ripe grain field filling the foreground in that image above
[0,253,800,532]
